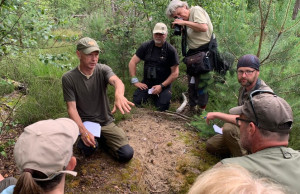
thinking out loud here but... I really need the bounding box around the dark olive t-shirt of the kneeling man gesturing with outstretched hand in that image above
[62,64,115,126]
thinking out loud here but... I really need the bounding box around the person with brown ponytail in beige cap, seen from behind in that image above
[1,118,79,194]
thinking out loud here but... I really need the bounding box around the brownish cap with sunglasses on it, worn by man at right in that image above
[229,92,293,133]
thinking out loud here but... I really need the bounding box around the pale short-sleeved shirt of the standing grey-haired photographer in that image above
[187,6,213,49]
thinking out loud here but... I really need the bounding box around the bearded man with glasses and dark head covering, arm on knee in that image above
[206,54,272,158]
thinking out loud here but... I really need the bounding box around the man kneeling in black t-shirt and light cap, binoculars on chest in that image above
[129,23,179,111]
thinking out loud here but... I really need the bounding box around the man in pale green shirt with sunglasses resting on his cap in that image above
[216,90,300,193]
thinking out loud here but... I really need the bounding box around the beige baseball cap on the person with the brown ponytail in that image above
[14,118,79,181]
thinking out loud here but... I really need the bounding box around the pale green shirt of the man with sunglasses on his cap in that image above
[221,147,300,193]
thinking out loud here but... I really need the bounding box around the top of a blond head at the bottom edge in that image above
[188,164,287,194]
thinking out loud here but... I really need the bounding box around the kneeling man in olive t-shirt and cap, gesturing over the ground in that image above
[62,37,134,162]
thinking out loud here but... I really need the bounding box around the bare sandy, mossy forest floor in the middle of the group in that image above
[0,92,218,193]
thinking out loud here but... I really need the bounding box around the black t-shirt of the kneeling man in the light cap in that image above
[135,40,179,87]
